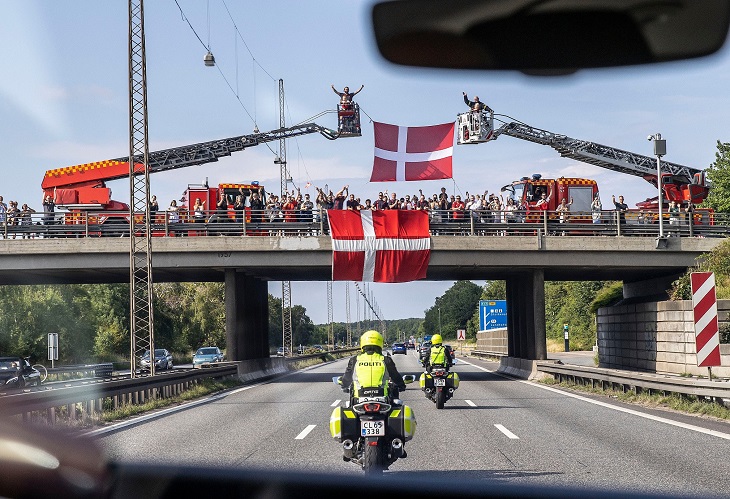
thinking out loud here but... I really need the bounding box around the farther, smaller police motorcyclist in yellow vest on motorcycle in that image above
[419,334,459,409]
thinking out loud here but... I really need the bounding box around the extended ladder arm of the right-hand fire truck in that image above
[494,122,702,184]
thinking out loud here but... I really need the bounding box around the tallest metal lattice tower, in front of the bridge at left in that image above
[129,0,155,378]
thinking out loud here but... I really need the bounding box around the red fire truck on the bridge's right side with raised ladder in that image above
[457,111,710,217]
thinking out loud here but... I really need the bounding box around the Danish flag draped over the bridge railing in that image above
[327,210,431,282]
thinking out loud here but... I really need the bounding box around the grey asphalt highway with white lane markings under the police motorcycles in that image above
[97,351,730,497]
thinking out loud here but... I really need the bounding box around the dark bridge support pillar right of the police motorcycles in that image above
[506,269,547,360]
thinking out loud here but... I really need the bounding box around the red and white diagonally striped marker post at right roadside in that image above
[690,272,720,380]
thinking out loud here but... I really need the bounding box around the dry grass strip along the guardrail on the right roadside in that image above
[539,377,730,420]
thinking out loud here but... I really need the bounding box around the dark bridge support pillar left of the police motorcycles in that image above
[225,269,269,360]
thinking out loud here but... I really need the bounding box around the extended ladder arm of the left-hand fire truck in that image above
[41,123,338,193]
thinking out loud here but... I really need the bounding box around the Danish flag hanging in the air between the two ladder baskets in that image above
[370,122,454,182]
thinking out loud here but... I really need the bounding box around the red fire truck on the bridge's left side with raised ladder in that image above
[41,123,340,230]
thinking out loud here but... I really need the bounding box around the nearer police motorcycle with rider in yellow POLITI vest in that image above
[330,331,416,473]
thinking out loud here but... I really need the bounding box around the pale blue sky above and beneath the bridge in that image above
[0,0,730,323]
